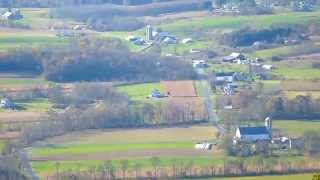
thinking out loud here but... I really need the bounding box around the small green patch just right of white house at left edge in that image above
[16,98,52,112]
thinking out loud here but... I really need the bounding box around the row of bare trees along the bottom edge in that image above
[47,156,319,179]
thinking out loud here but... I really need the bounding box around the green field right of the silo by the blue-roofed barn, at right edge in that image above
[273,120,320,137]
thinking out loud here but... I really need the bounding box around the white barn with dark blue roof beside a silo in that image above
[236,126,271,141]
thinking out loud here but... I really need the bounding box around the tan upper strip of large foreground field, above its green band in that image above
[31,126,215,145]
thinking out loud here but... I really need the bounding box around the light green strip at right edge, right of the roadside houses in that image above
[273,67,320,80]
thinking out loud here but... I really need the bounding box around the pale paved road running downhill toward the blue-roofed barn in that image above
[195,68,225,133]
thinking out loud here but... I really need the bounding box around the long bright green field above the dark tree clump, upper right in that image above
[161,11,320,34]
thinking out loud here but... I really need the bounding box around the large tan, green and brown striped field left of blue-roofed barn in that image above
[30,126,219,178]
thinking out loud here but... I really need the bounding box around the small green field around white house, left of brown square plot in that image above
[117,83,163,100]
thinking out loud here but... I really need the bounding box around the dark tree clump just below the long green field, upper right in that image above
[221,25,303,47]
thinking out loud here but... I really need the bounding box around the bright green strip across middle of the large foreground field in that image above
[31,142,193,156]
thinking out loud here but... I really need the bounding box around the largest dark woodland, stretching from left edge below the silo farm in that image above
[0,39,196,82]
